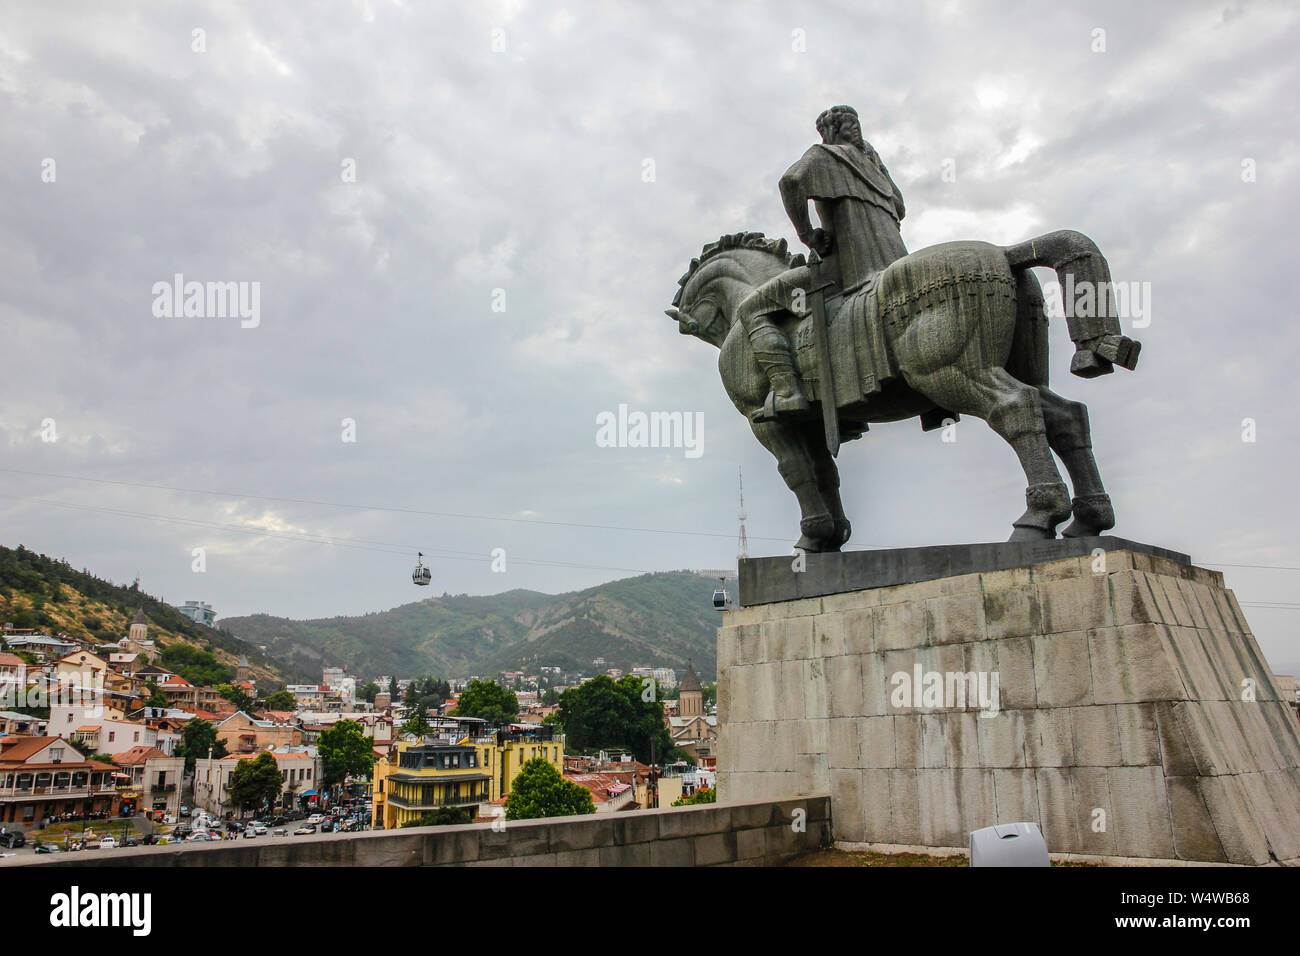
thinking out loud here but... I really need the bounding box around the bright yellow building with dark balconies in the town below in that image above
[373,727,564,830]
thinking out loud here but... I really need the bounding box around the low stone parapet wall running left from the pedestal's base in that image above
[0,795,831,869]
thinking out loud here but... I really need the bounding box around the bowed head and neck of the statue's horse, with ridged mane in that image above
[664,233,803,347]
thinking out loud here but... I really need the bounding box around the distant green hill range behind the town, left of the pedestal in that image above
[221,571,719,680]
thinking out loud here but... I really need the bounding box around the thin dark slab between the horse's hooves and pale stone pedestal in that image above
[725,535,1191,606]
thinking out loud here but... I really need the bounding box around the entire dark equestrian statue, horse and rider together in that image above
[667,107,1141,551]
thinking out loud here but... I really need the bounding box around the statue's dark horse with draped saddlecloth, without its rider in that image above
[667,230,1140,551]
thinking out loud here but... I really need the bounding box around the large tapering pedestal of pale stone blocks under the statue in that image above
[718,538,1300,864]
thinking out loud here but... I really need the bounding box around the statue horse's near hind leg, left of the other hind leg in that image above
[911,365,1070,541]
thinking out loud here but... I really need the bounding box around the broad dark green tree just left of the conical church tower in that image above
[558,674,676,763]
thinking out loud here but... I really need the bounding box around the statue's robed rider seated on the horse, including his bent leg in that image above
[740,107,907,415]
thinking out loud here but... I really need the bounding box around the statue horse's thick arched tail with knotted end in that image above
[1004,229,1141,378]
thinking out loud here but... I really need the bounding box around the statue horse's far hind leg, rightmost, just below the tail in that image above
[1006,269,1115,537]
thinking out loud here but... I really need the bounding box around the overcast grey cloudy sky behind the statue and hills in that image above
[0,0,1300,667]
